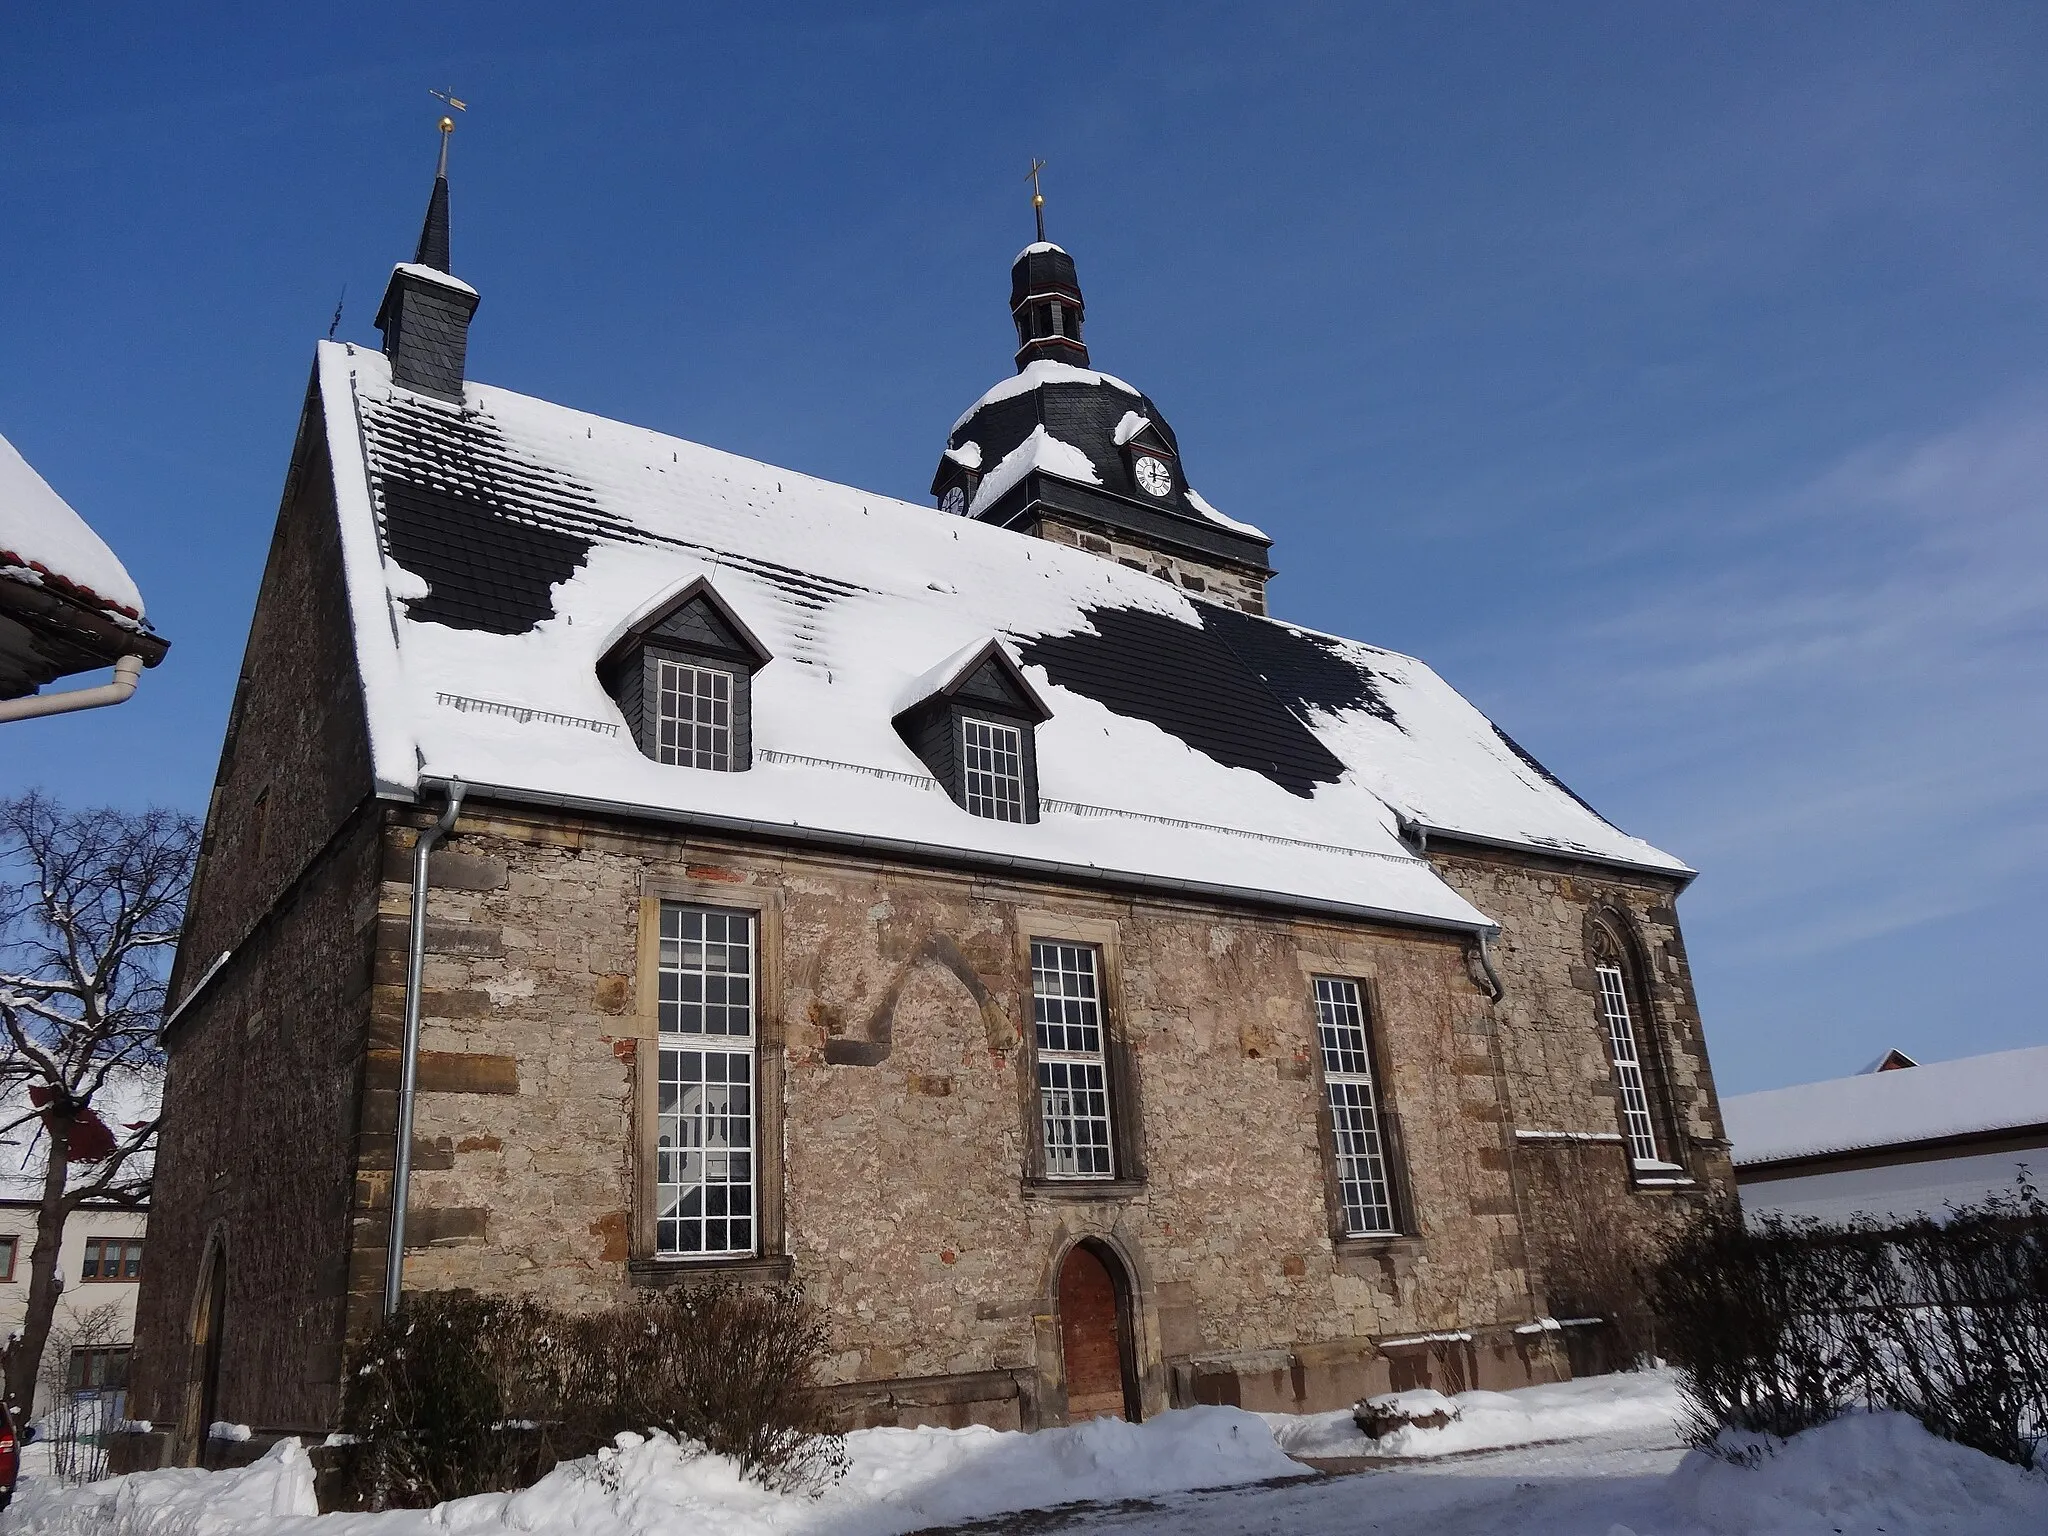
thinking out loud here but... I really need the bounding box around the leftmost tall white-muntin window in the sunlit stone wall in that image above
[655,901,760,1257]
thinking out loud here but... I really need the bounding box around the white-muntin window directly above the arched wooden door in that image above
[1030,938,1116,1180]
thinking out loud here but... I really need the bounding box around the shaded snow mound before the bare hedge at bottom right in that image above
[1667,1413,2048,1536]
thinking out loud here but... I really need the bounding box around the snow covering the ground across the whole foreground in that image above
[0,1372,2048,1536]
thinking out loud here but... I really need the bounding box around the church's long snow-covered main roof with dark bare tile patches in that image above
[319,344,1683,928]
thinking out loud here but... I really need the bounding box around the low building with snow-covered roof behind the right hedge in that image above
[1720,1044,2048,1221]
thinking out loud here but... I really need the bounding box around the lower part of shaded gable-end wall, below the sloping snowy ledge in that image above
[129,807,379,1464]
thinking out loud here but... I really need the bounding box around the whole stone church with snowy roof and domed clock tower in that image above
[119,162,1731,1460]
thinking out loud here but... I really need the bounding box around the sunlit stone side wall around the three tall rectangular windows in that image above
[339,807,1556,1423]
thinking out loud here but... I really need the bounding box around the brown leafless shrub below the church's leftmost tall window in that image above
[338,1282,846,1507]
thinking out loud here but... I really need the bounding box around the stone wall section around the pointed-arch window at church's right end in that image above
[1430,842,1735,1313]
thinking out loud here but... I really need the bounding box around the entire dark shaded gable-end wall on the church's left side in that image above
[117,422,381,1464]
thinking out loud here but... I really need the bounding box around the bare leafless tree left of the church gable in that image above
[0,791,199,1413]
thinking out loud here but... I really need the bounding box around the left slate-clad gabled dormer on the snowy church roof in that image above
[598,580,770,774]
